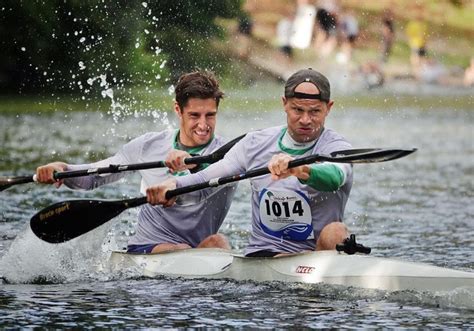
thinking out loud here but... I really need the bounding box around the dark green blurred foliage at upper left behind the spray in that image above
[0,0,241,95]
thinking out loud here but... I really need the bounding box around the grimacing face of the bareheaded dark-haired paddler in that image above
[174,98,217,147]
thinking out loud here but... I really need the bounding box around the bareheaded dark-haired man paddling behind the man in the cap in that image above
[36,71,235,253]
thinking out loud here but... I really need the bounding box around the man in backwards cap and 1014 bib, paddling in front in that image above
[147,69,352,257]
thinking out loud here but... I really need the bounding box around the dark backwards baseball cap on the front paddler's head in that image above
[285,68,331,102]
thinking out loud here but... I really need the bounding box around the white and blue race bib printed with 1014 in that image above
[259,189,314,241]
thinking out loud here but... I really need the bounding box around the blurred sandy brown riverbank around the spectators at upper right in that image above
[226,0,474,96]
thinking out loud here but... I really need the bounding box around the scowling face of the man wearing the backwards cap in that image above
[283,82,334,143]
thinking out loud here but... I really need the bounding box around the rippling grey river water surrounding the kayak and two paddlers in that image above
[0,86,474,328]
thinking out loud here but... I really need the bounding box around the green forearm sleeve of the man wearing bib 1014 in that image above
[300,163,344,192]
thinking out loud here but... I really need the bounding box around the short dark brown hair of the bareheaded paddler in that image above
[175,71,224,111]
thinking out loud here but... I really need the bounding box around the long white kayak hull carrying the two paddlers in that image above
[110,248,474,291]
